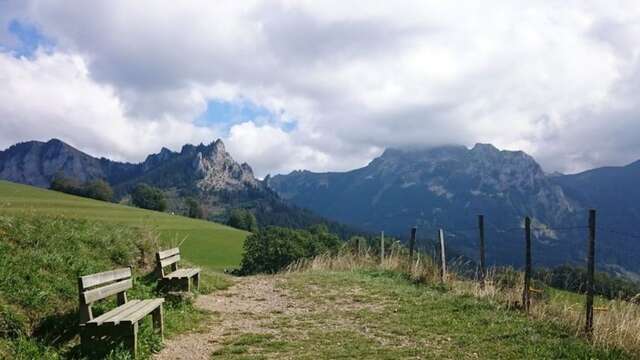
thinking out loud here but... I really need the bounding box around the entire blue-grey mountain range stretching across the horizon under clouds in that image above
[0,139,640,276]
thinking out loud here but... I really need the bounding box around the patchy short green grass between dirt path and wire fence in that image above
[212,270,632,360]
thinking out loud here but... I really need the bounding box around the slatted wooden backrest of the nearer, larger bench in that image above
[78,267,133,324]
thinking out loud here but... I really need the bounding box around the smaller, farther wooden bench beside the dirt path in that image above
[156,248,200,291]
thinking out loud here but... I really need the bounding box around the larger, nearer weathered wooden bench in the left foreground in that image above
[78,268,164,358]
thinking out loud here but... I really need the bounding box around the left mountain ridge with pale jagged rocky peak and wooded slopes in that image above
[0,139,351,235]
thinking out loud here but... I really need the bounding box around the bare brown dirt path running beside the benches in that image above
[154,276,304,360]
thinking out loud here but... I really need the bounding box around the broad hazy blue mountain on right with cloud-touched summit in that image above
[269,144,640,272]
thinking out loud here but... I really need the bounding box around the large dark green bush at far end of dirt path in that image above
[240,225,340,275]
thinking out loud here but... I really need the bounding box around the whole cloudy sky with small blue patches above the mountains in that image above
[0,0,640,176]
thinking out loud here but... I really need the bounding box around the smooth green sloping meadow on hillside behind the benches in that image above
[0,181,248,270]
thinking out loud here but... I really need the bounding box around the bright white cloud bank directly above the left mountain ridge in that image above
[0,52,215,160]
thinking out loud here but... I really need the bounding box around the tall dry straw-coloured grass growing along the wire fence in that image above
[287,246,640,356]
